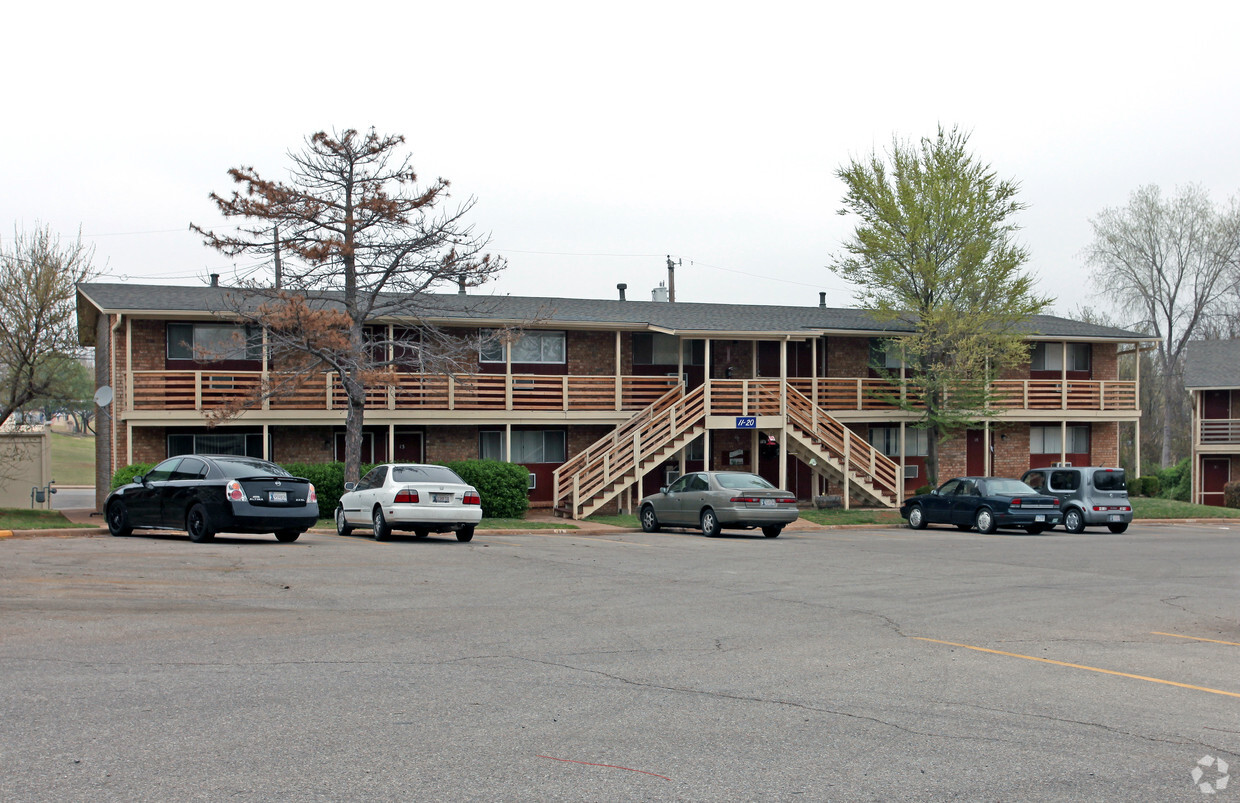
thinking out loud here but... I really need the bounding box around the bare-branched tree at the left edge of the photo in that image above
[0,227,94,424]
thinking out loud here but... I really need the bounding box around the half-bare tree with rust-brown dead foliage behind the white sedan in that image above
[191,129,505,480]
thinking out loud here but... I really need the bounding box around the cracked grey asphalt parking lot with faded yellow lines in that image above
[0,524,1240,801]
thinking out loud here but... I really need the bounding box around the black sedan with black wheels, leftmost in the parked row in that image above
[103,455,319,542]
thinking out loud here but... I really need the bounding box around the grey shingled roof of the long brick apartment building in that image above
[78,283,1156,344]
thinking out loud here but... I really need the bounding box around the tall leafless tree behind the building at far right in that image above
[1086,185,1240,467]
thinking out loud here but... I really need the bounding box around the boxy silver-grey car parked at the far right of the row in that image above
[1021,466,1132,533]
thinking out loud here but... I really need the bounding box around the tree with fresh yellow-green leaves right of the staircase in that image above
[831,126,1050,483]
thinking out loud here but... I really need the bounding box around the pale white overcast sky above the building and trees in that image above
[0,0,1240,322]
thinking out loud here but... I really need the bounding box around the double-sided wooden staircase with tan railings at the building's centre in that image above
[553,380,900,519]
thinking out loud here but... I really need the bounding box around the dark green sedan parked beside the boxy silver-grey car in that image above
[900,477,1061,534]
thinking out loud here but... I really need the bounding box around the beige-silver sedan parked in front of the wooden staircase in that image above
[637,471,799,538]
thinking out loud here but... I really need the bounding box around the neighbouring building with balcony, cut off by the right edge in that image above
[1184,340,1240,506]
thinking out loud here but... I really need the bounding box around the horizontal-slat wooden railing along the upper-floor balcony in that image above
[131,371,1137,415]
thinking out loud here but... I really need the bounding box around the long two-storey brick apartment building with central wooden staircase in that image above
[78,284,1154,517]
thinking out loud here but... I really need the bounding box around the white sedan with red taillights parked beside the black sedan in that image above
[336,463,482,542]
